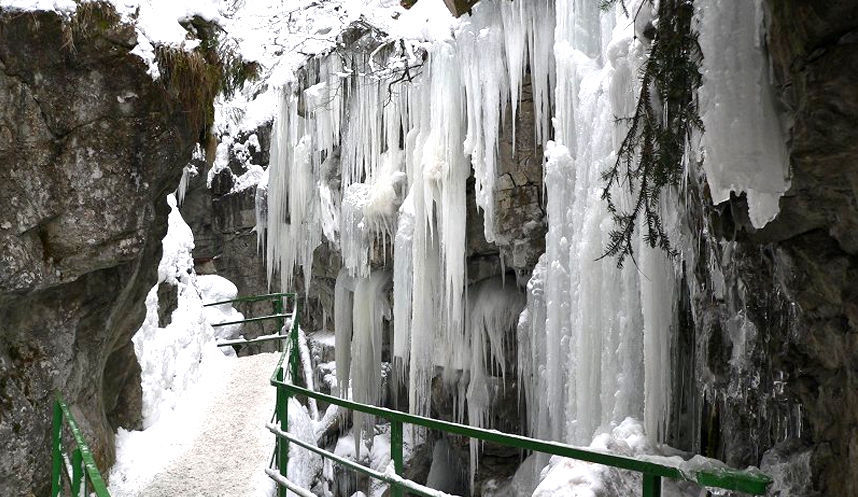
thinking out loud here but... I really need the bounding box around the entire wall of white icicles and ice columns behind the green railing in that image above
[260,0,784,490]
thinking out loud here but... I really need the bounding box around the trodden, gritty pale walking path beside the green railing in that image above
[137,354,279,497]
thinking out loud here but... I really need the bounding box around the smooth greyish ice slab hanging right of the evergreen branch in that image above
[696,0,789,228]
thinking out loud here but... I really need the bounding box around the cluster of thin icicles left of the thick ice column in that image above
[259,0,554,468]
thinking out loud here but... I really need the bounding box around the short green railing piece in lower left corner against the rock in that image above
[51,392,110,497]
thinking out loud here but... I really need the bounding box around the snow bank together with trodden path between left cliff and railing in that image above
[109,194,282,497]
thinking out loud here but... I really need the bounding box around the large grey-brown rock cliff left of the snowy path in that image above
[0,4,211,496]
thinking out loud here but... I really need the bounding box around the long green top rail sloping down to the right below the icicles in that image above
[271,378,772,495]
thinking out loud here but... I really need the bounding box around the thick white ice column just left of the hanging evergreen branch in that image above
[519,0,674,450]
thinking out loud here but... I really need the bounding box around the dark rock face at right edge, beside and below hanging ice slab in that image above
[675,0,858,495]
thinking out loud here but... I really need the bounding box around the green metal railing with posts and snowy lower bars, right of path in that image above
[266,303,772,497]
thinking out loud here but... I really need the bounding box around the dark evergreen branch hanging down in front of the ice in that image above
[599,0,703,267]
